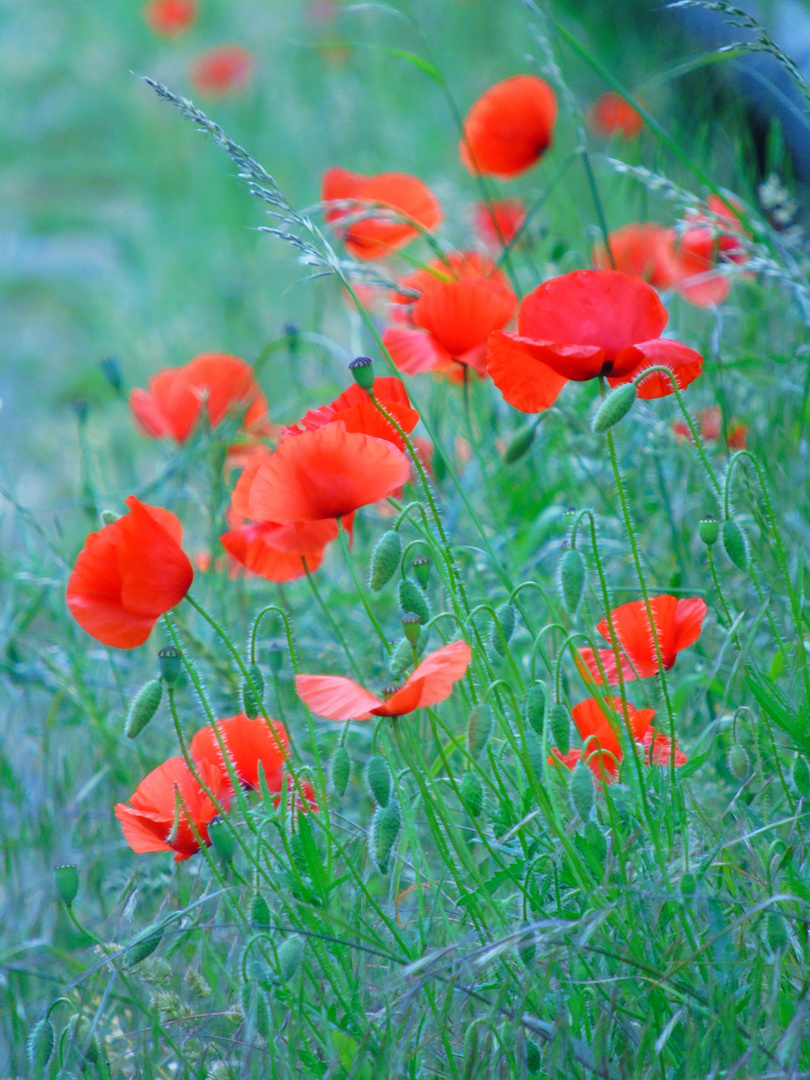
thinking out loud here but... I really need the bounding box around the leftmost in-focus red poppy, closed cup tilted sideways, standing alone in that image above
[66,496,194,649]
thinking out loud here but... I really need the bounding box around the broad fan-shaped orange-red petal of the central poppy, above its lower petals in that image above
[248,420,410,525]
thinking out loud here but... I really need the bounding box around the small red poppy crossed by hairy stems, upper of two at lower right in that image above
[580,595,706,684]
